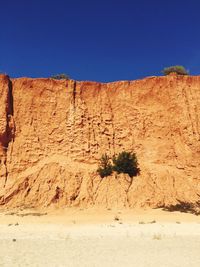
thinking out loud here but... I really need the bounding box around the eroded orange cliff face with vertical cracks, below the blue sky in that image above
[0,76,200,210]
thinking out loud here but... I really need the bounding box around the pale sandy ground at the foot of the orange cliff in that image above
[0,208,200,267]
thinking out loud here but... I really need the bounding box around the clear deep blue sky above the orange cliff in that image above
[0,0,200,81]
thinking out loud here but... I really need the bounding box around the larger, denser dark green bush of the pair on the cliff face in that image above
[113,151,140,177]
